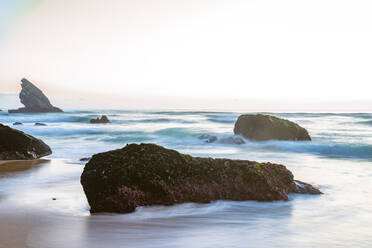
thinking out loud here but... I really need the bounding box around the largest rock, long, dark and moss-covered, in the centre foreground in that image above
[81,144,321,213]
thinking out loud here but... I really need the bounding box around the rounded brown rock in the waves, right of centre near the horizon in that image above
[234,114,311,141]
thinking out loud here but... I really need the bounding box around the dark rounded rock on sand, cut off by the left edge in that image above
[0,124,52,160]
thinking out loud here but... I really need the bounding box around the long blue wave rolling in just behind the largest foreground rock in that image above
[11,121,372,159]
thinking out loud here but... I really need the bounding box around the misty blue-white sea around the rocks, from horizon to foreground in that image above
[0,110,372,248]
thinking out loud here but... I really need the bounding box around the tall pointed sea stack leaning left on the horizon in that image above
[8,78,63,113]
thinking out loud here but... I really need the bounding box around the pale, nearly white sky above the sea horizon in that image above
[0,0,372,112]
